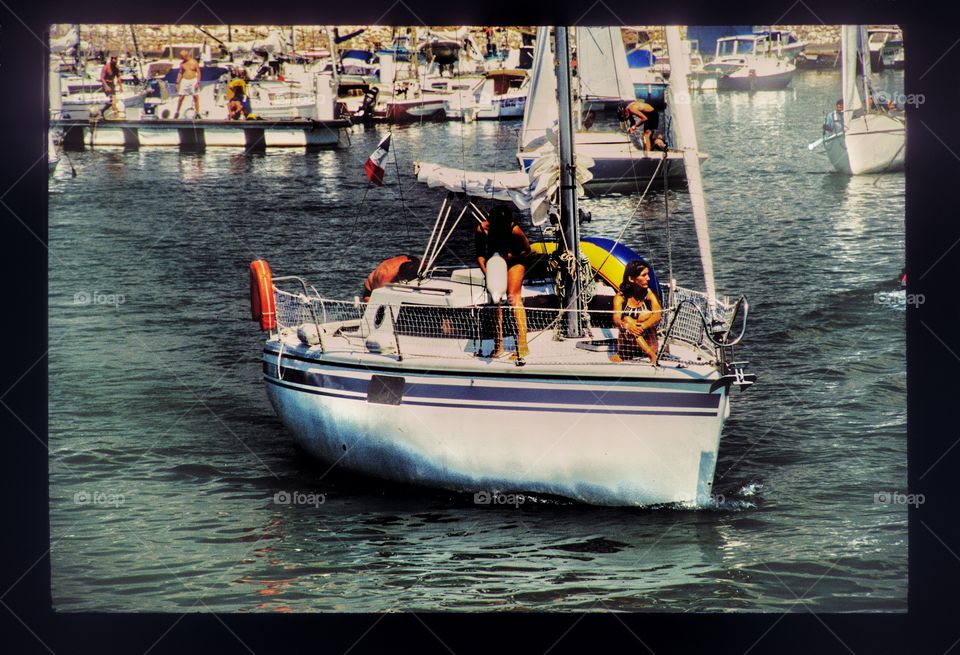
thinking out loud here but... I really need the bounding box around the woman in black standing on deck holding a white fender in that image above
[474,205,532,359]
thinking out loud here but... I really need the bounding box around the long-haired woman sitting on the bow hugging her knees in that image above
[610,259,661,362]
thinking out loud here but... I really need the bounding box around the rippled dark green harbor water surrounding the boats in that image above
[49,72,908,612]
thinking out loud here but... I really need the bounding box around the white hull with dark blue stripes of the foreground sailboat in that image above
[263,343,729,505]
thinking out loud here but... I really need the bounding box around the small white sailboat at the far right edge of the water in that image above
[810,25,906,175]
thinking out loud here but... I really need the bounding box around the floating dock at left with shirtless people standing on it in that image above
[50,118,351,150]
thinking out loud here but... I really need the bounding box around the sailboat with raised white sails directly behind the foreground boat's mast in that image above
[517,27,696,196]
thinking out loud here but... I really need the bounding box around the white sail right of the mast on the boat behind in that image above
[577,27,635,100]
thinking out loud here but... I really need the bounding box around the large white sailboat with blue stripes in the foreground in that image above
[251,27,755,506]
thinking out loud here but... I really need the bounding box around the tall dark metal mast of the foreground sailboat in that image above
[556,27,583,338]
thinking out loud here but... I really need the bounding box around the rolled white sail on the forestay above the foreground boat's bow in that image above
[666,25,717,311]
